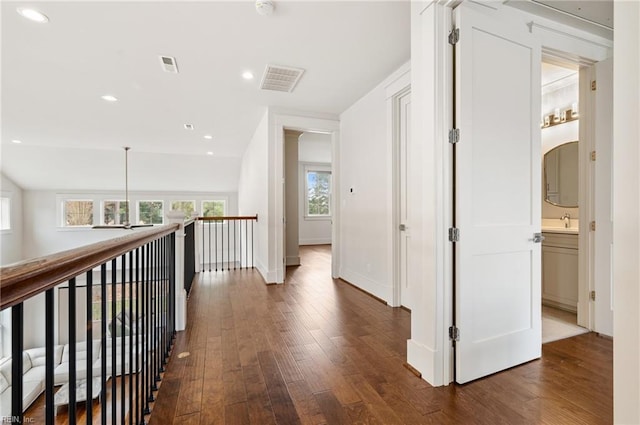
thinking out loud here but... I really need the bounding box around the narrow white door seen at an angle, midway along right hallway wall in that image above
[397,93,419,309]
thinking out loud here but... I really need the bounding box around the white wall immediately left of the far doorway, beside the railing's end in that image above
[238,111,275,283]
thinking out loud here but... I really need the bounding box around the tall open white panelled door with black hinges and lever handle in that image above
[454,3,541,383]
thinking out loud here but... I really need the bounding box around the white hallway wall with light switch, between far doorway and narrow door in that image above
[339,68,393,302]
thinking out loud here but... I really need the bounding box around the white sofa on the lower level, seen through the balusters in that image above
[0,336,144,418]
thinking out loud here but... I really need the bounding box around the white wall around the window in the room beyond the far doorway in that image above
[298,133,331,245]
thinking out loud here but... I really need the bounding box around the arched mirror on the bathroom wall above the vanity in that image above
[544,141,578,208]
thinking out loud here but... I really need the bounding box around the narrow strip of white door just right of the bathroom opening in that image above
[593,59,613,336]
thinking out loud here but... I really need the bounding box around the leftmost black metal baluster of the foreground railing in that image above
[11,303,24,424]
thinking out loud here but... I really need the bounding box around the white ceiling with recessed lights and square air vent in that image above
[1,1,410,191]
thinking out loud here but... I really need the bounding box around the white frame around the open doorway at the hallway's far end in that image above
[269,110,340,283]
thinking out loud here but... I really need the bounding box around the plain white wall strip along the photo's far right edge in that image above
[613,1,640,424]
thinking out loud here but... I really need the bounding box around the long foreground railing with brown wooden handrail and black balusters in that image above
[0,224,180,425]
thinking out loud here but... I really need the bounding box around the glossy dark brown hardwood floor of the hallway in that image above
[144,246,613,425]
